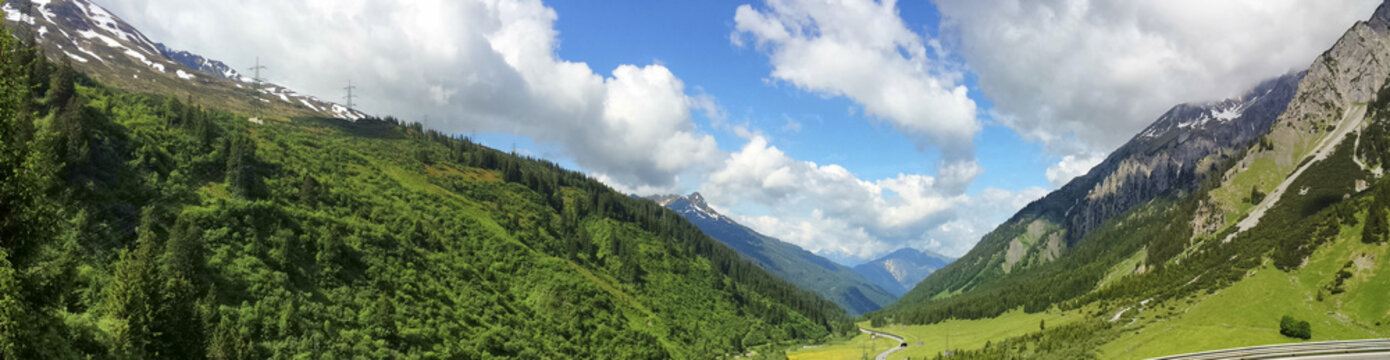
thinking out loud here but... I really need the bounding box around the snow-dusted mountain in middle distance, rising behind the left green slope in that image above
[649,193,898,316]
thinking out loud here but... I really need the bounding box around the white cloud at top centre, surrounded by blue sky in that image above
[731,0,980,193]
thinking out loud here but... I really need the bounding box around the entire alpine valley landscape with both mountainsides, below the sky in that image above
[0,0,1390,359]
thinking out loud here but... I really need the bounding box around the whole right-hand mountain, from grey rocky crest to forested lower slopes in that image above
[869,1,1390,347]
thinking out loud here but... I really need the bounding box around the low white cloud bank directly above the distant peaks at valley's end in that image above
[701,136,1044,263]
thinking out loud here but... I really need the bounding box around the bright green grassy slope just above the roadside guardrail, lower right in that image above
[1098,219,1390,359]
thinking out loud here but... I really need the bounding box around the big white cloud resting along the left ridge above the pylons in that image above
[104,0,723,192]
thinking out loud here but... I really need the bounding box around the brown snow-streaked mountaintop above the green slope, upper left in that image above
[3,0,367,120]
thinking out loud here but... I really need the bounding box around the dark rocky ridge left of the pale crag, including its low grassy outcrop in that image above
[919,66,1305,297]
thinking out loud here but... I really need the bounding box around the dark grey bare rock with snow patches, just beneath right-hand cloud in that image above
[1050,72,1304,246]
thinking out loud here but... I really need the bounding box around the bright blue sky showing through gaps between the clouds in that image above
[492,0,1059,193]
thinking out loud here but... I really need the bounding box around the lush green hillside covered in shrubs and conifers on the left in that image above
[0,27,853,359]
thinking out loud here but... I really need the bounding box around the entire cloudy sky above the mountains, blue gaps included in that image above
[97,0,1379,265]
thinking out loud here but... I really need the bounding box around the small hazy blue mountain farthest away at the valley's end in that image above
[855,247,955,296]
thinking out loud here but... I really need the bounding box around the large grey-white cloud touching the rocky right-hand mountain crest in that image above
[935,0,1380,158]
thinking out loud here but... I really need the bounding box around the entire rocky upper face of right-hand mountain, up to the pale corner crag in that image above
[919,3,1390,304]
